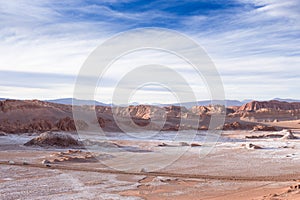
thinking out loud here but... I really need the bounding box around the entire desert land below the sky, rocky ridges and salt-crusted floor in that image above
[0,100,300,200]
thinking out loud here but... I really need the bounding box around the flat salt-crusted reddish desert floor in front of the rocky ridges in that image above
[0,130,300,200]
